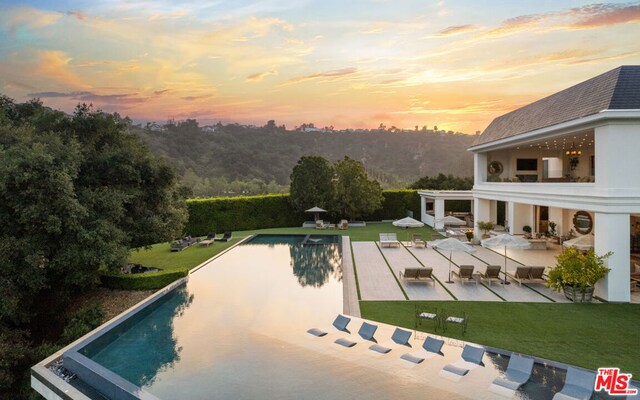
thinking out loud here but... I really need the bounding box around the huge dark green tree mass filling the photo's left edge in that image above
[0,97,186,327]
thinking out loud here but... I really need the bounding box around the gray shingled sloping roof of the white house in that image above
[474,65,640,146]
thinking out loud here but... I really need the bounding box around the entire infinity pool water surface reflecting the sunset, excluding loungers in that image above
[76,235,620,400]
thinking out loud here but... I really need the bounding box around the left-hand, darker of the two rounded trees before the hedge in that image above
[290,156,333,212]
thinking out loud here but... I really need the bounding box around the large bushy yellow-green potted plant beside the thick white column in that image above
[547,248,613,303]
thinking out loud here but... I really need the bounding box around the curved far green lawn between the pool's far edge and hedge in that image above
[129,222,439,271]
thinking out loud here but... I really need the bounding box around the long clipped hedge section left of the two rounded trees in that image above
[185,194,305,236]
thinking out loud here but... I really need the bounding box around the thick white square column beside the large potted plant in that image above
[594,212,631,303]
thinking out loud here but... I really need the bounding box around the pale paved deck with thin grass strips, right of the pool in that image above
[344,242,569,304]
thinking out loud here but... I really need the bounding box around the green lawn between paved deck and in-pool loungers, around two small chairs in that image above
[360,301,640,377]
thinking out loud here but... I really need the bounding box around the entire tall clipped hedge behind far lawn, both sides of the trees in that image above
[185,190,420,236]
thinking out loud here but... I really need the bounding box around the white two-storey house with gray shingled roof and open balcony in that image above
[469,66,640,302]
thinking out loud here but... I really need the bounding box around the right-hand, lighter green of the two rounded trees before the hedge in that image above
[333,156,383,220]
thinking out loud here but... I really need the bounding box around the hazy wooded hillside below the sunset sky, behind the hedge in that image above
[131,120,474,196]
